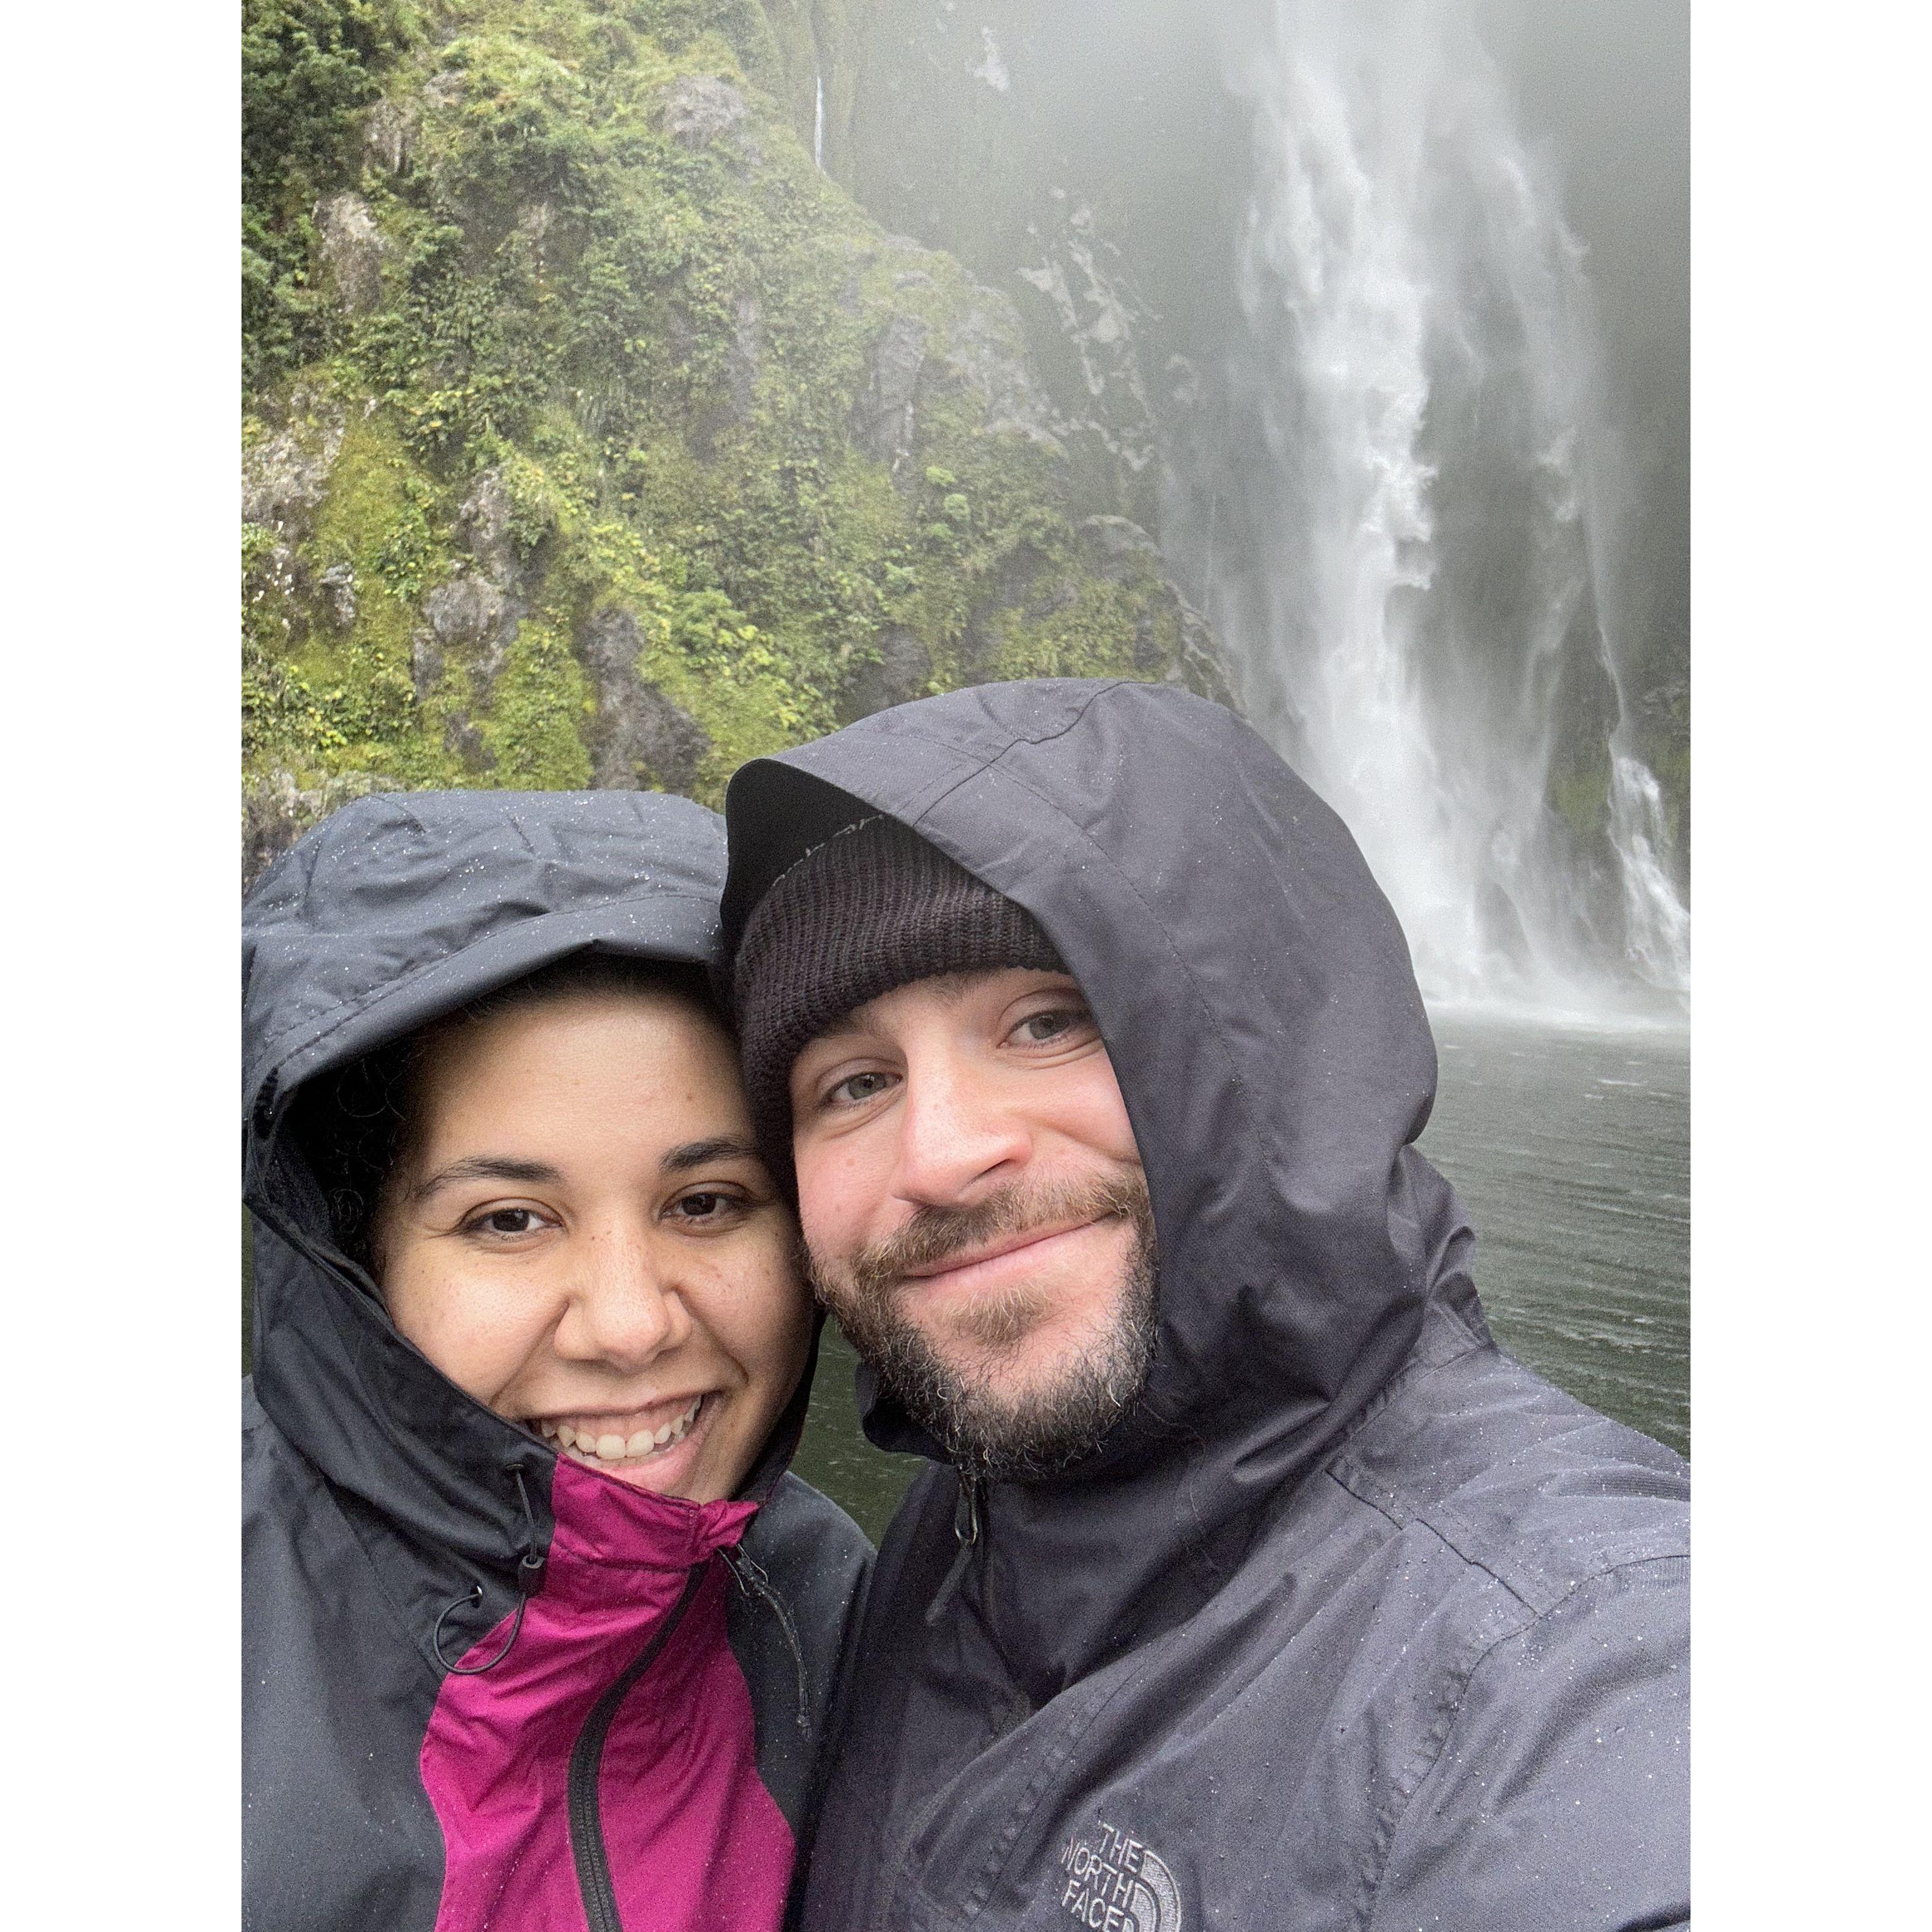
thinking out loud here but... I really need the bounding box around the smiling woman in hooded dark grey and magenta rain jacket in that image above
[243,792,870,1932]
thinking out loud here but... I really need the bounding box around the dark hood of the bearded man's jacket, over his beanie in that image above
[724,680,1480,1692]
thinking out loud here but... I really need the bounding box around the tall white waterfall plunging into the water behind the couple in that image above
[1175,0,1689,1010]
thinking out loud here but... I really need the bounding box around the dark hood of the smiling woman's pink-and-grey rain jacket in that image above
[242,792,810,1630]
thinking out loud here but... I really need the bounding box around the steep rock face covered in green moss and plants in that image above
[243,0,1225,885]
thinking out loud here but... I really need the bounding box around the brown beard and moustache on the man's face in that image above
[808,1177,1157,1482]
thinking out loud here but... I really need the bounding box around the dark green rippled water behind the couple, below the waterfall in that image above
[796,1014,1690,1542]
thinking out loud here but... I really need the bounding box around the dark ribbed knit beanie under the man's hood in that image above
[732,817,1067,1192]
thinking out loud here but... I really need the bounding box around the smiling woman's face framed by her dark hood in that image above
[373,993,810,1503]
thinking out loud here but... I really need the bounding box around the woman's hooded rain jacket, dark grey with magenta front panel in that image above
[242,792,870,1932]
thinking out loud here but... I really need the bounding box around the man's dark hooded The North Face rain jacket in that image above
[724,682,1689,1932]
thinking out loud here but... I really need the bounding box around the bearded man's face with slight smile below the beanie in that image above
[792,968,1156,1478]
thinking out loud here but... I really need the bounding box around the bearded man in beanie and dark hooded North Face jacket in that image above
[724,682,1689,1932]
